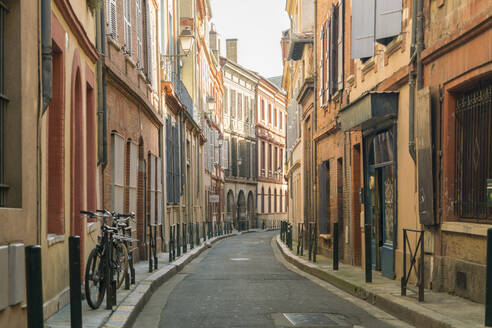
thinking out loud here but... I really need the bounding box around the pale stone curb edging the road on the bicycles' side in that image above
[101,232,236,328]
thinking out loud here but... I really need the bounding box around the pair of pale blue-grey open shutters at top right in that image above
[351,0,402,58]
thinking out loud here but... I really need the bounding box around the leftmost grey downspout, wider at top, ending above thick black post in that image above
[36,0,53,245]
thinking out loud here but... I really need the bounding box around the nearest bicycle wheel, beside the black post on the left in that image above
[85,248,106,309]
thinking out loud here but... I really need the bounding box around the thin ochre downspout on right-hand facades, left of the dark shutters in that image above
[311,0,319,224]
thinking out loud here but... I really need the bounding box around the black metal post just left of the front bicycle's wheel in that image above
[68,236,82,328]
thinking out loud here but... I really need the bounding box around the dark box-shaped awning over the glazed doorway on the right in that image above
[339,92,398,131]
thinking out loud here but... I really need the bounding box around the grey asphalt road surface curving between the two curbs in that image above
[134,232,408,328]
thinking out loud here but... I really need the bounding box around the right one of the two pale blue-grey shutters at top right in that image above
[376,0,402,41]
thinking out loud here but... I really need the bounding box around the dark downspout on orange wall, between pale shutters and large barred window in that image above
[408,0,420,163]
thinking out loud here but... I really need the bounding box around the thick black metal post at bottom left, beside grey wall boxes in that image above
[25,245,44,328]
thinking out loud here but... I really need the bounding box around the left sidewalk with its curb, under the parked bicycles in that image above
[44,231,238,328]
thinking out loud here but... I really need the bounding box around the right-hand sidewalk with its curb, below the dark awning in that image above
[276,236,485,328]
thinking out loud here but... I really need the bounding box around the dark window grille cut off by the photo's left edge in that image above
[0,1,9,207]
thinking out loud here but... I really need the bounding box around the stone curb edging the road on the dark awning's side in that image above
[274,235,464,328]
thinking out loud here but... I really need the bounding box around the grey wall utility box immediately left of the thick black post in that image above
[8,243,26,305]
